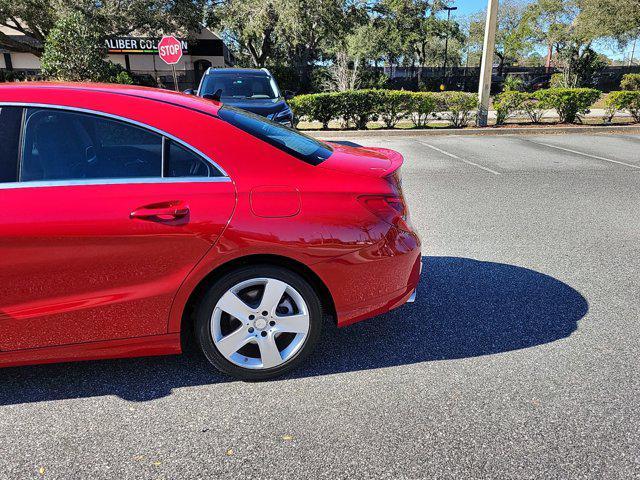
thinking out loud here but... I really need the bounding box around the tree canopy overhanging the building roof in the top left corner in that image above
[0,0,205,57]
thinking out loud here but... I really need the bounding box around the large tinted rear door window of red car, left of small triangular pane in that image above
[19,108,162,182]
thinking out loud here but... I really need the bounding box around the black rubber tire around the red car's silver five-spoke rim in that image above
[194,265,323,381]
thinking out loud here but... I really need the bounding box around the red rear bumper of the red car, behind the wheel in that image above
[314,228,422,327]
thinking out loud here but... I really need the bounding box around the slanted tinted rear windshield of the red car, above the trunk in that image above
[218,105,333,165]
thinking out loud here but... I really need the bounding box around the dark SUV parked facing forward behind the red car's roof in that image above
[197,68,293,127]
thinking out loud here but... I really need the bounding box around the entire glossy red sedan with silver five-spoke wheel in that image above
[0,83,421,380]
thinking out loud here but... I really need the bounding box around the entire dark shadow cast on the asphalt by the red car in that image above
[0,257,589,405]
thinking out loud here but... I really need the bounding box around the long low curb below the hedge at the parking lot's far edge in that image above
[301,125,640,140]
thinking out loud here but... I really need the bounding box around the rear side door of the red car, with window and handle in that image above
[0,105,235,351]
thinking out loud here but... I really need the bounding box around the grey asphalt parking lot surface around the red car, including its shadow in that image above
[0,134,640,479]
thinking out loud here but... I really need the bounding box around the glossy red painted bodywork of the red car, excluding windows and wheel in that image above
[0,84,421,366]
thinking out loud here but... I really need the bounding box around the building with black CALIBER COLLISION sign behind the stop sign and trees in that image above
[0,27,233,89]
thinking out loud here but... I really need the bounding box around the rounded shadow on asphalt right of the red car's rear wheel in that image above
[296,257,589,376]
